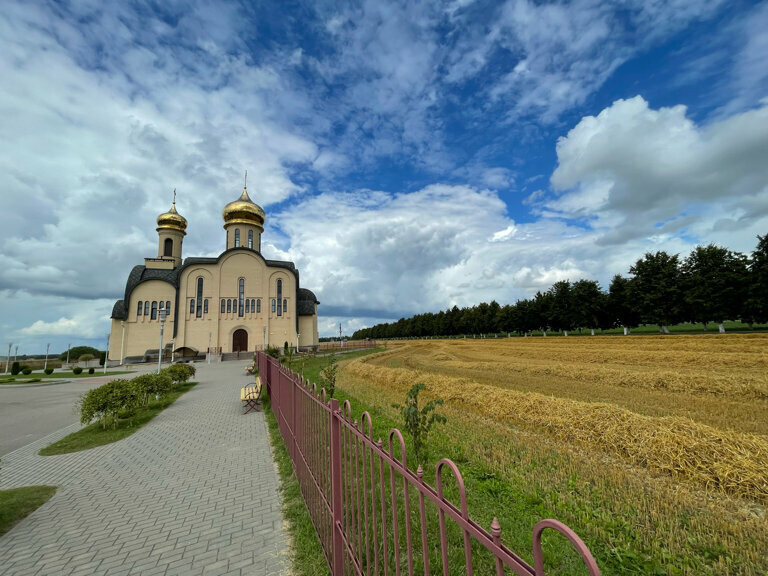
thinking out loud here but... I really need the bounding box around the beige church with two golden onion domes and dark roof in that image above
[108,184,320,364]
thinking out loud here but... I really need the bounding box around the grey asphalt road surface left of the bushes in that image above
[0,366,154,456]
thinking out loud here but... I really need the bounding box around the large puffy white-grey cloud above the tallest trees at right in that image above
[540,96,768,249]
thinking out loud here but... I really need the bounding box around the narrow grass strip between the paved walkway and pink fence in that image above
[264,398,330,576]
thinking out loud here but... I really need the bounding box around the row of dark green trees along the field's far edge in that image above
[352,234,768,339]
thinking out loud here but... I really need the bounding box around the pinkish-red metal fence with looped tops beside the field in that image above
[258,353,600,576]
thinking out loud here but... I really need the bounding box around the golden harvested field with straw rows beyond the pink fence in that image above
[341,335,768,575]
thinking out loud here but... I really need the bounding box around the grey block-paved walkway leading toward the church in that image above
[0,362,290,576]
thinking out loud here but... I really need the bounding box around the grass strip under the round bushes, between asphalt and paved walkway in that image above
[38,382,197,456]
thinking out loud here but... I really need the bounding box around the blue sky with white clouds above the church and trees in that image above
[0,0,768,353]
